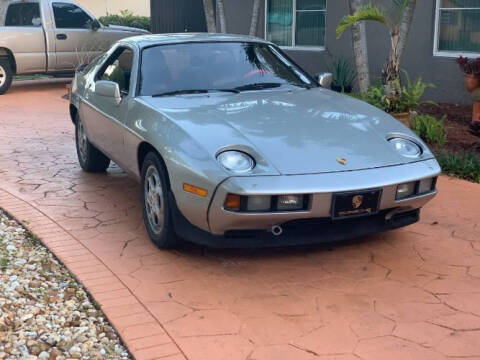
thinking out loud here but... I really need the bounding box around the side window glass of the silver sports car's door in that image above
[96,48,133,96]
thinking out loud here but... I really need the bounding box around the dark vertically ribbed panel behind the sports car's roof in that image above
[150,0,207,34]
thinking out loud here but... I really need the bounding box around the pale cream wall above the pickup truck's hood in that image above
[75,0,150,17]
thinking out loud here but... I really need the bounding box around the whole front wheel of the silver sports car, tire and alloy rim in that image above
[142,152,179,249]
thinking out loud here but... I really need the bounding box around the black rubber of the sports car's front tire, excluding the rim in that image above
[141,152,178,249]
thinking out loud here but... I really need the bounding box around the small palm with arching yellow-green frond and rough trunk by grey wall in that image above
[337,0,416,94]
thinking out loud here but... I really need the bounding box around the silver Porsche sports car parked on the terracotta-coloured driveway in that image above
[70,34,440,248]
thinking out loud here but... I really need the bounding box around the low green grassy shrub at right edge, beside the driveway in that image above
[437,151,480,183]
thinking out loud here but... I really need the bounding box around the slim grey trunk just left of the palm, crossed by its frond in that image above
[349,0,370,93]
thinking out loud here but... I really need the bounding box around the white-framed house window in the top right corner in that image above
[436,0,480,56]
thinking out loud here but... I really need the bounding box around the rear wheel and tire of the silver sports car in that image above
[75,115,110,173]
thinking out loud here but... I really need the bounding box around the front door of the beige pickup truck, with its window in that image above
[52,2,103,71]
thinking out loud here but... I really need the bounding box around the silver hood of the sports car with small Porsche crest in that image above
[142,88,433,175]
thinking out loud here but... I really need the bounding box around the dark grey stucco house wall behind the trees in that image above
[219,0,471,104]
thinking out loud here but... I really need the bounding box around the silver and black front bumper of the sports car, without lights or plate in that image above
[170,159,441,248]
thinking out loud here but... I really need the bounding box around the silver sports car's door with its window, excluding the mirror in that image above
[82,45,137,165]
